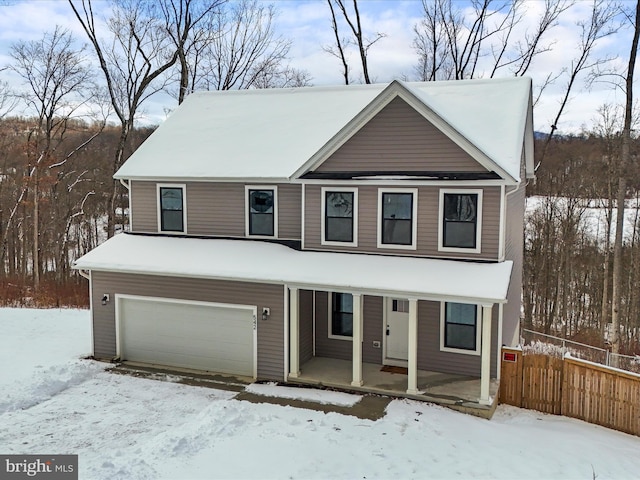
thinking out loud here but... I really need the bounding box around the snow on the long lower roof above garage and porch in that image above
[74,233,512,303]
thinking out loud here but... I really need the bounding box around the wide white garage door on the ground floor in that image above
[118,296,256,377]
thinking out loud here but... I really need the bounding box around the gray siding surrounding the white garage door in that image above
[91,271,284,380]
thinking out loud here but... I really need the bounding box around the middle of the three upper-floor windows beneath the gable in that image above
[378,188,418,250]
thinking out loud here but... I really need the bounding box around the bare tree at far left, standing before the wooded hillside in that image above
[3,27,90,289]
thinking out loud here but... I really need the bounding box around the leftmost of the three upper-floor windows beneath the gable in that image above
[321,188,358,246]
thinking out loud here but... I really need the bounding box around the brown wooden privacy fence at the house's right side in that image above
[500,347,640,436]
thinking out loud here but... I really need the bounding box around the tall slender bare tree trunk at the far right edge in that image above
[611,1,640,366]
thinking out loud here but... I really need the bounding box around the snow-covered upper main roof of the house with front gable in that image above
[115,78,531,181]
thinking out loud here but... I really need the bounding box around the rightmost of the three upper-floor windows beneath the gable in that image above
[439,190,482,253]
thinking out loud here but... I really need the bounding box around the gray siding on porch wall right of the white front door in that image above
[418,300,498,377]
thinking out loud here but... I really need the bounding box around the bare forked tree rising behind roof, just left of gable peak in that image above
[324,0,386,85]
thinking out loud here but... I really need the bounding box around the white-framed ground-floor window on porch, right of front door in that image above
[440,302,480,355]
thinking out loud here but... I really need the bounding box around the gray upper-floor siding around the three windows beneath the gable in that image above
[304,184,500,260]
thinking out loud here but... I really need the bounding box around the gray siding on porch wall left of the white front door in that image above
[315,291,382,363]
